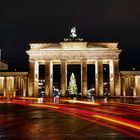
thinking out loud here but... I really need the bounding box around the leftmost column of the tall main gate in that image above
[28,61,35,97]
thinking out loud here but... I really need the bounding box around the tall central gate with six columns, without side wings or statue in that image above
[26,41,121,97]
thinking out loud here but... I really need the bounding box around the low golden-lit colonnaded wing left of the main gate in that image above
[0,72,28,97]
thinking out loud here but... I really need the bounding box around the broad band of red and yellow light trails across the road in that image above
[0,99,140,139]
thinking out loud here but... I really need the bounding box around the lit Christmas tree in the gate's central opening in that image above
[68,73,78,95]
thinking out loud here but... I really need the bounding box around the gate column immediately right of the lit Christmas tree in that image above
[81,60,87,97]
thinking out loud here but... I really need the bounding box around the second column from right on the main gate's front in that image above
[95,60,103,96]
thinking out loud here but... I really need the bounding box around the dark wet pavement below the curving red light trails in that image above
[0,103,137,140]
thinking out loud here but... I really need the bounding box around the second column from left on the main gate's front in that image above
[45,60,53,97]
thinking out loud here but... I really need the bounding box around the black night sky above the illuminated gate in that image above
[0,0,140,71]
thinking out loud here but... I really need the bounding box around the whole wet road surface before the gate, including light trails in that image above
[0,100,140,140]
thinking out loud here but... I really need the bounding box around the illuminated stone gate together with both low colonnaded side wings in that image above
[0,41,140,97]
